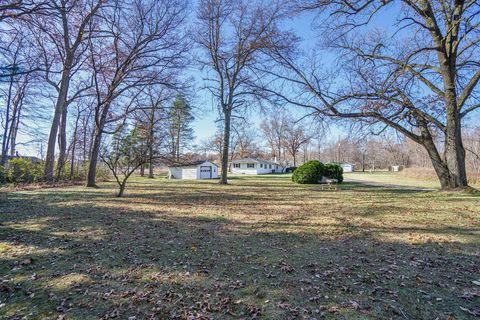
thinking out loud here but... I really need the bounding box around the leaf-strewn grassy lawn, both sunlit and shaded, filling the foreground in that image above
[0,175,480,320]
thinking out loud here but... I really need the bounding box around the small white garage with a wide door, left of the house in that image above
[168,160,218,180]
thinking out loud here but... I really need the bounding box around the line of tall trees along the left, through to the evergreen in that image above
[0,0,193,186]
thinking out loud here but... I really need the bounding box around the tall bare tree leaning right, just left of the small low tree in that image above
[87,0,188,187]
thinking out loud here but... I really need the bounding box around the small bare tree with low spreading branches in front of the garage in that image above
[100,128,148,197]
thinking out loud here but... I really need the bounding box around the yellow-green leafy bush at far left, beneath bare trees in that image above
[6,158,42,184]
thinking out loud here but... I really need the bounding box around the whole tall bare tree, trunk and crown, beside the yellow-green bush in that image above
[22,0,105,182]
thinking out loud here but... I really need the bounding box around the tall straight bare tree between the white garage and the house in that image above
[195,0,281,184]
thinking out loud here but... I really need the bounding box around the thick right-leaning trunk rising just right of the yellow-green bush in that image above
[44,64,70,182]
